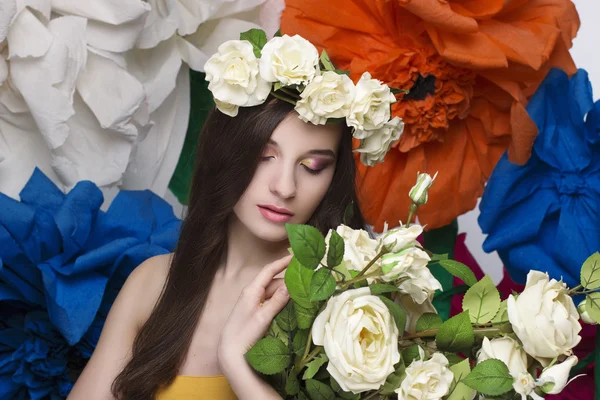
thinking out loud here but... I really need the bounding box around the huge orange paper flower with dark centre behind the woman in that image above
[281,0,579,230]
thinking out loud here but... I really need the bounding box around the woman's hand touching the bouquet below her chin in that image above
[217,255,292,375]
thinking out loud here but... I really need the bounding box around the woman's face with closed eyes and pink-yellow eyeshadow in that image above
[233,112,341,242]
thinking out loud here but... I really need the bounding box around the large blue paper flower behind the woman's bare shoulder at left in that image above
[0,169,180,399]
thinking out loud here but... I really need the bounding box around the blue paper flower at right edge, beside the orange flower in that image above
[479,69,600,287]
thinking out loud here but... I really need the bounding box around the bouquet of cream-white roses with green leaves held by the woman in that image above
[246,174,600,400]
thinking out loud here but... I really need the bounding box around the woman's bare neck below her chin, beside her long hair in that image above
[222,217,289,277]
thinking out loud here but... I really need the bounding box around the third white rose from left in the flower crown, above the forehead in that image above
[296,71,354,125]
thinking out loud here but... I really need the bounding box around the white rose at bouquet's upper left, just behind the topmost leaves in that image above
[325,225,381,271]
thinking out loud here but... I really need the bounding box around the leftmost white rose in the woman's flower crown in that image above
[204,40,272,108]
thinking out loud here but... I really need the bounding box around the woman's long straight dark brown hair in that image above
[112,101,364,400]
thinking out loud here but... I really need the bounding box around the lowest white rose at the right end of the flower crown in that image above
[353,117,404,167]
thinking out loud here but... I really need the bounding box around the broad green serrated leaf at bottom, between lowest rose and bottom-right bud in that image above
[463,359,513,396]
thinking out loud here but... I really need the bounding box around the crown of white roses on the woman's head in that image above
[204,29,404,166]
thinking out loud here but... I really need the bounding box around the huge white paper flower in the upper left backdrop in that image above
[0,0,283,203]
